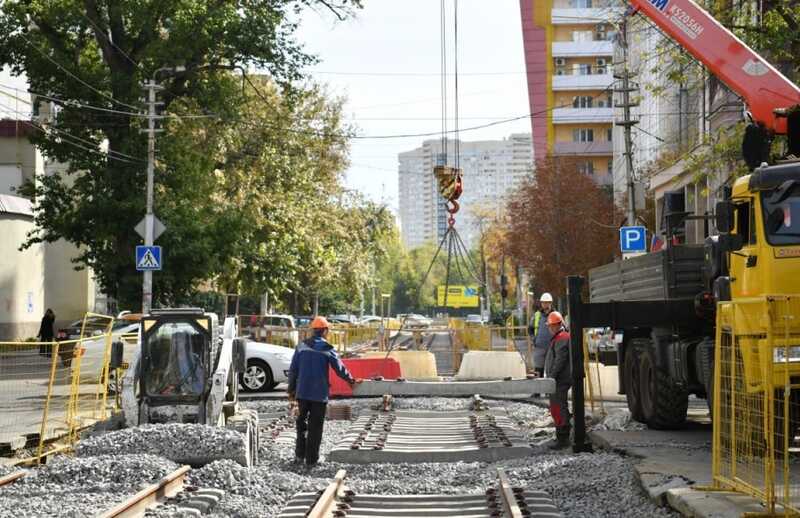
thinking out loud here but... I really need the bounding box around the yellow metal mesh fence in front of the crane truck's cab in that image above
[712,295,800,516]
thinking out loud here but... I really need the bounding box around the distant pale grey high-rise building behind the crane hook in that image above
[397,133,533,248]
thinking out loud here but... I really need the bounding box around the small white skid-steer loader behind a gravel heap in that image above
[122,308,259,465]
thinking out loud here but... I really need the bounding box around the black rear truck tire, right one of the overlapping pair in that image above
[639,341,689,430]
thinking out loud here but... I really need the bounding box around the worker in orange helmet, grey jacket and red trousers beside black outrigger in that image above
[544,311,572,450]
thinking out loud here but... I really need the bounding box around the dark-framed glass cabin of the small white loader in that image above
[141,311,216,406]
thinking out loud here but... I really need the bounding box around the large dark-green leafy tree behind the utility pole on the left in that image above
[0,0,360,306]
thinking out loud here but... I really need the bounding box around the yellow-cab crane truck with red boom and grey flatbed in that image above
[568,0,800,456]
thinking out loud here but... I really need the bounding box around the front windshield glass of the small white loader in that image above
[145,323,205,396]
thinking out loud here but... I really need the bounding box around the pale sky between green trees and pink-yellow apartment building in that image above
[298,0,530,209]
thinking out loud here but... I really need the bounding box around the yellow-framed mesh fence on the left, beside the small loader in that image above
[0,313,114,468]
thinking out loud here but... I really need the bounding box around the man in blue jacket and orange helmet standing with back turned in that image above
[288,317,361,468]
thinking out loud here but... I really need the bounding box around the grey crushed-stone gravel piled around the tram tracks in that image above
[0,398,678,518]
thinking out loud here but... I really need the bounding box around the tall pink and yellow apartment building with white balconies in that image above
[520,0,621,185]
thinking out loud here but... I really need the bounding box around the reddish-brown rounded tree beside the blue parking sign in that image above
[505,158,621,295]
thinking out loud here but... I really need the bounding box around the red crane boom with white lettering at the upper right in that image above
[629,0,800,135]
